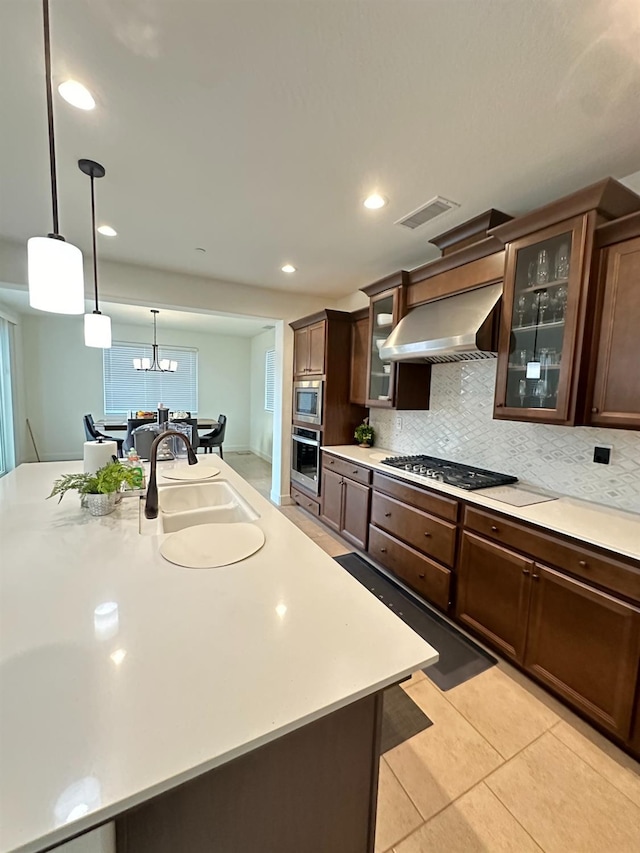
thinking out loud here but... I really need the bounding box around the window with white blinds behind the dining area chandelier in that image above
[102,342,198,415]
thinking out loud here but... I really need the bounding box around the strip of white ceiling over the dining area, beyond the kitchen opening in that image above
[0,287,274,339]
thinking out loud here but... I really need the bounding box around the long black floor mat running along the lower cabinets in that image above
[335,554,497,690]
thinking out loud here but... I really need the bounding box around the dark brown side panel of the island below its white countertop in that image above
[116,693,382,853]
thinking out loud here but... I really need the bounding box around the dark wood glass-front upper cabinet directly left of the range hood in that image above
[362,270,431,410]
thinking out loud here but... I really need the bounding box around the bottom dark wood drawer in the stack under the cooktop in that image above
[368,525,451,610]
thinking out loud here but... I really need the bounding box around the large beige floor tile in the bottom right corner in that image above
[486,732,640,853]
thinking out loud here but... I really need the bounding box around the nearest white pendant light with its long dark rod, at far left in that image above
[27,0,84,314]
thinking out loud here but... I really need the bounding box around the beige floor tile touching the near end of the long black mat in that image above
[445,666,558,758]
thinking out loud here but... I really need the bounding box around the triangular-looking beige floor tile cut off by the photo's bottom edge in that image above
[393,782,540,853]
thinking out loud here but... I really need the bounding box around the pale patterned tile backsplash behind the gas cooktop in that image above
[371,360,640,512]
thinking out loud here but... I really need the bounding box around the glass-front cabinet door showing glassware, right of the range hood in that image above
[494,216,586,423]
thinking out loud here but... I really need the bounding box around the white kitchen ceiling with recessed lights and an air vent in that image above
[0,0,640,296]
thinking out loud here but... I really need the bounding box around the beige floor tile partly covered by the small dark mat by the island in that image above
[385,678,503,820]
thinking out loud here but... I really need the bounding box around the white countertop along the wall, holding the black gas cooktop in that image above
[322,445,640,560]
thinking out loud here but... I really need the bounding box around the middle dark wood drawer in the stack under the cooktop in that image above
[371,491,456,567]
